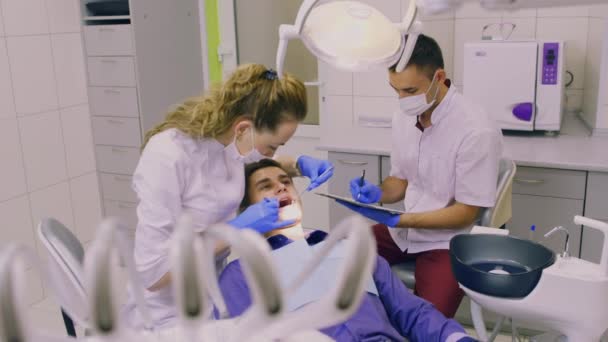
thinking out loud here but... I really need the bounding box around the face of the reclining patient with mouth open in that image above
[248,166,302,225]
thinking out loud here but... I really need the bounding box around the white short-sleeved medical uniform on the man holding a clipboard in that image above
[389,85,502,253]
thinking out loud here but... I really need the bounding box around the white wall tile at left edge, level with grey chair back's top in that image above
[0,196,36,256]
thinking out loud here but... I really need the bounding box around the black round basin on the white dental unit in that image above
[450,234,555,298]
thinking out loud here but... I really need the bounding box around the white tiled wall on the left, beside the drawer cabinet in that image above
[0,0,101,302]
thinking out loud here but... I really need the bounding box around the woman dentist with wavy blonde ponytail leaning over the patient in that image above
[123,64,333,328]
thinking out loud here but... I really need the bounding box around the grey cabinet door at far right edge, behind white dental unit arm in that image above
[581,172,608,263]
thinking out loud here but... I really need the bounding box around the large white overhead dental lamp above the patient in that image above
[277,0,422,77]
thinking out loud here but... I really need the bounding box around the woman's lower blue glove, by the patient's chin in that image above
[228,198,296,234]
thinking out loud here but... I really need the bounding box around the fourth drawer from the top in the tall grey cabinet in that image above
[92,116,141,147]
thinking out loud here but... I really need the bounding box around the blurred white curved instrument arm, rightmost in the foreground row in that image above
[251,216,376,338]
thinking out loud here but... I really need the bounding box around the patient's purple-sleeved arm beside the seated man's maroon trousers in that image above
[374,257,474,341]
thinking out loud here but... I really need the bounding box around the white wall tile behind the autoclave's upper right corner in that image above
[536,18,588,89]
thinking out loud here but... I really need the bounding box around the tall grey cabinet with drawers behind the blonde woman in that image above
[79,0,203,229]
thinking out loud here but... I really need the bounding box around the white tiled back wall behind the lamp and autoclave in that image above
[320,0,608,141]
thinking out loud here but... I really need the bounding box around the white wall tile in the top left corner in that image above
[0,0,49,36]
